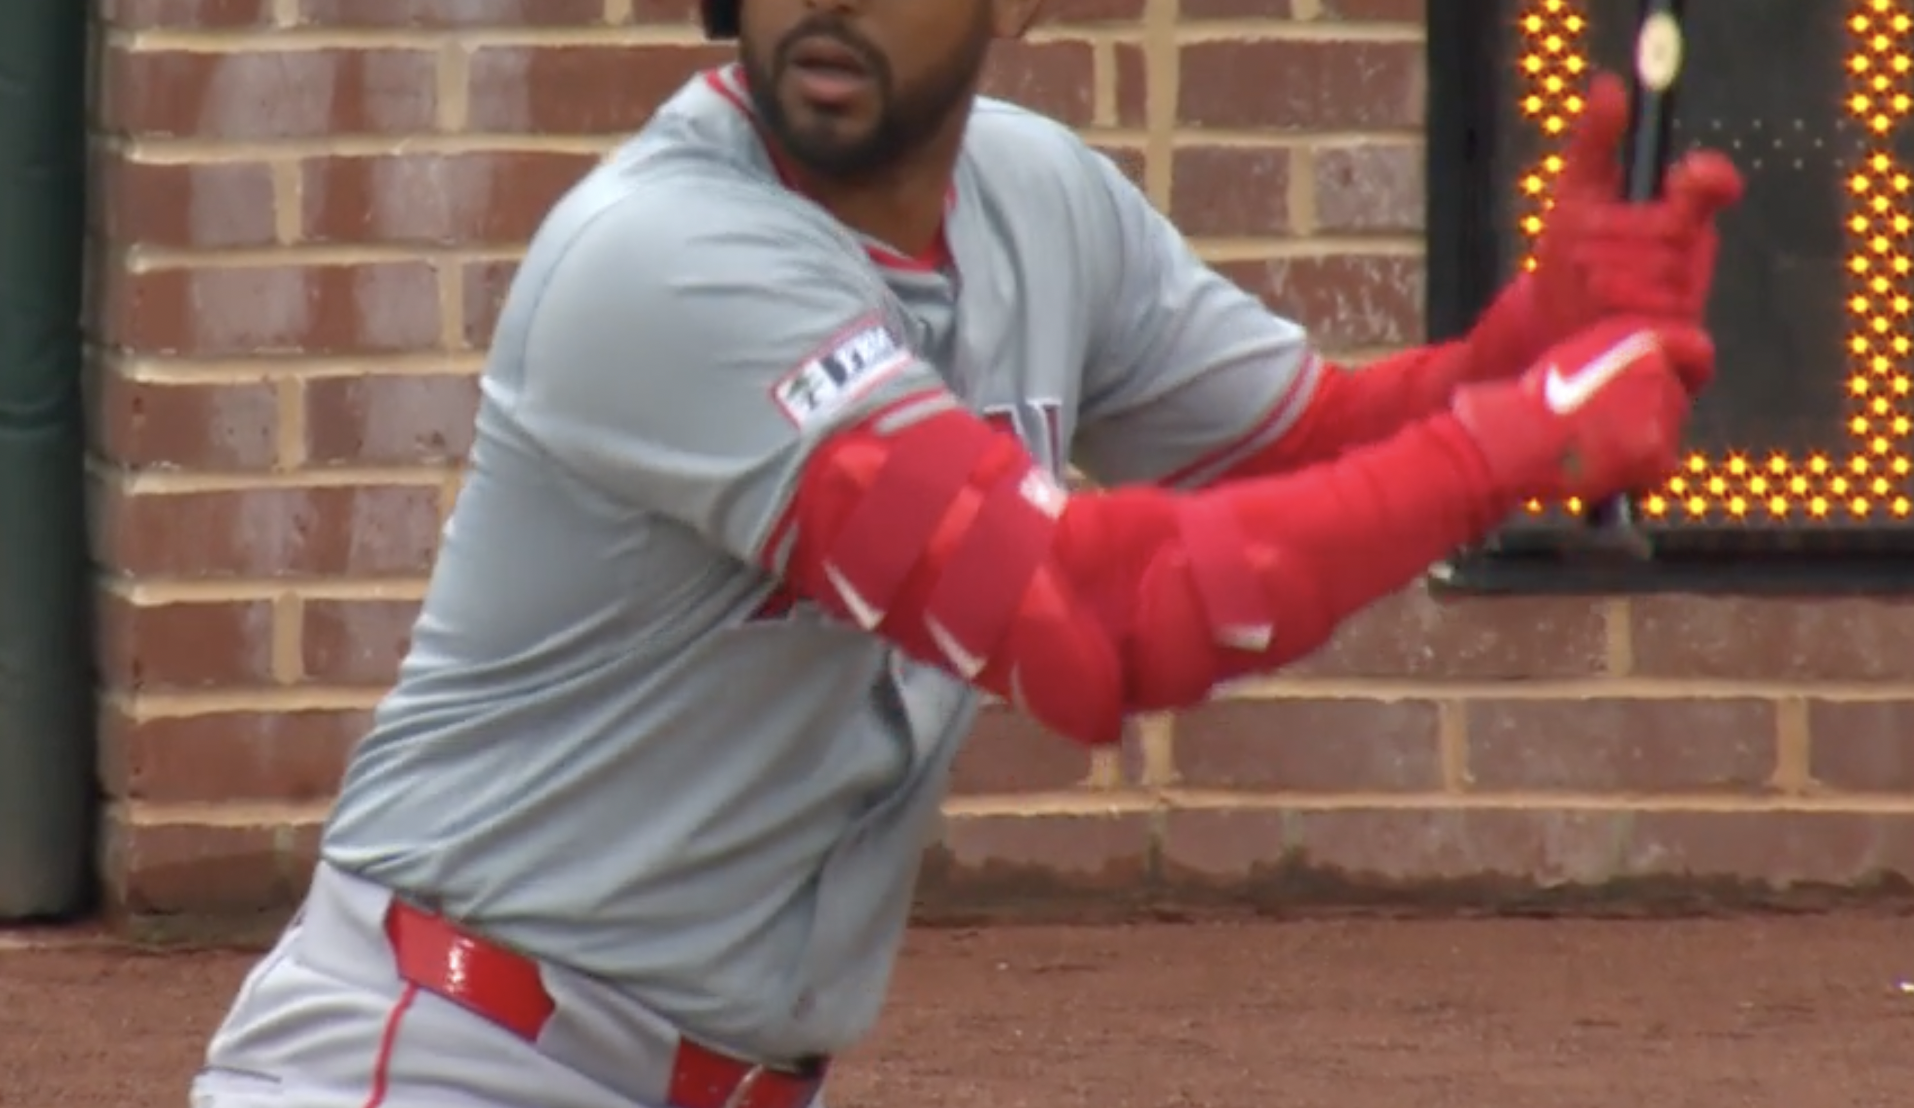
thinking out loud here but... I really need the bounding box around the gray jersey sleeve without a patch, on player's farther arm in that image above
[1074,149,1323,486]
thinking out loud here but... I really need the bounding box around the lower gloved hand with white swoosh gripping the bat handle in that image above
[1453,320,1715,499]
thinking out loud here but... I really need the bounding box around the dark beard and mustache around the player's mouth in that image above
[739,4,991,180]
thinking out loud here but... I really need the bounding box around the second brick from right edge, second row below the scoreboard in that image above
[1466,698,1776,794]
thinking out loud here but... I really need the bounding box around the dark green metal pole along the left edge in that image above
[0,0,96,919]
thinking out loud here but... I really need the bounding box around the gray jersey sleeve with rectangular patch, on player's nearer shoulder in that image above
[509,174,940,561]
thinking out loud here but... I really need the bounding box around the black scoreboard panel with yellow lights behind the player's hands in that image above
[1430,0,1914,587]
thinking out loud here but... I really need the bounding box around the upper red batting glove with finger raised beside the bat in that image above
[1464,73,1744,390]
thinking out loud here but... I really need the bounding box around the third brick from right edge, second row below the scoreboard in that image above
[1175,698,1441,792]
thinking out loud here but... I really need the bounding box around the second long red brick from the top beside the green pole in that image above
[101,262,440,358]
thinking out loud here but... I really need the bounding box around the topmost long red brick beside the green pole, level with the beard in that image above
[100,46,438,142]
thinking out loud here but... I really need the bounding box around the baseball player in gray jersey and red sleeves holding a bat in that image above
[193,0,1740,1108]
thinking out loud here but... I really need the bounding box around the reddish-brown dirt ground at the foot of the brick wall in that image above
[0,917,1914,1108]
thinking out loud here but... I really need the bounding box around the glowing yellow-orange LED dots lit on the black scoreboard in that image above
[1516,0,1914,524]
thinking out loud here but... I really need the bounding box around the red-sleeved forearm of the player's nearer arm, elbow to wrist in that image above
[1058,411,1520,712]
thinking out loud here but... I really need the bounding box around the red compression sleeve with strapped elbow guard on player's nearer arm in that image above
[785,396,1512,742]
